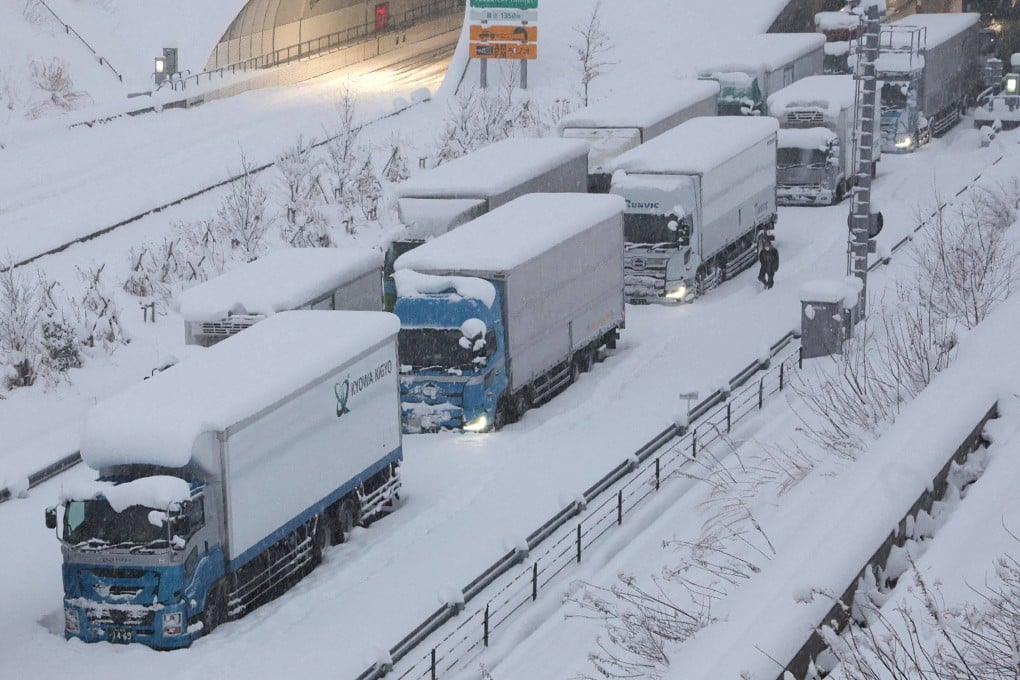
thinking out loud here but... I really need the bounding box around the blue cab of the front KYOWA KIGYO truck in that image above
[47,477,224,649]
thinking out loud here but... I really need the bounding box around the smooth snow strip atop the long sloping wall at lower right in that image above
[666,283,1020,680]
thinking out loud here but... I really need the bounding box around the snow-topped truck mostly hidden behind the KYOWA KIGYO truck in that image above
[179,248,383,347]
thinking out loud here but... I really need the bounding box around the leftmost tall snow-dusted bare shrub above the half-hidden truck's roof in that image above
[216,152,272,262]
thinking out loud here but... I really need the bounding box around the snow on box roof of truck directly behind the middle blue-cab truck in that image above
[396,138,588,199]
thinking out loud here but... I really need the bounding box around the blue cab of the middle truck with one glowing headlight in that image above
[394,272,508,432]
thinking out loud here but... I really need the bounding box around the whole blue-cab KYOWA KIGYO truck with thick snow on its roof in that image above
[46,311,402,649]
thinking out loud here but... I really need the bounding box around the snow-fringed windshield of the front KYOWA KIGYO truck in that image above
[63,501,169,550]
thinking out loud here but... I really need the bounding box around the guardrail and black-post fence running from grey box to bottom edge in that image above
[358,332,801,680]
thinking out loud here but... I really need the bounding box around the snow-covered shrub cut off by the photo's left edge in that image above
[0,261,46,389]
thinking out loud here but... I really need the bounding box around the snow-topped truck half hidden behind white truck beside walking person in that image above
[557,81,719,194]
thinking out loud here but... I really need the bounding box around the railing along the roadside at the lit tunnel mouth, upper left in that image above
[163,0,464,92]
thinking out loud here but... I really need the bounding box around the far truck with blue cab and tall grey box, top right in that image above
[875,12,981,153]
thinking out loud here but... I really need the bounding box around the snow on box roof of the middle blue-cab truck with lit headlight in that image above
[394,192,624,272]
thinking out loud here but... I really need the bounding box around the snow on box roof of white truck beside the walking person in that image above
[612,116,779,174]
